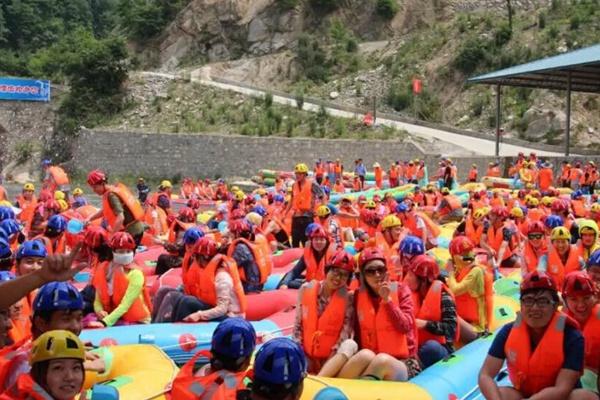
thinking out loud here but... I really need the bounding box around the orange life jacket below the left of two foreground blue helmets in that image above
[171,350,246,400]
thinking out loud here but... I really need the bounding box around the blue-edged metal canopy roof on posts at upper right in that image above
[467,44,600,93]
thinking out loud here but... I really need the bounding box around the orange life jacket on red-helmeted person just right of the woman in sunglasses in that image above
[412,280,460,346]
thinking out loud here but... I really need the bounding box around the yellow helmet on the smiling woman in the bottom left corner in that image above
[30,331,85,364]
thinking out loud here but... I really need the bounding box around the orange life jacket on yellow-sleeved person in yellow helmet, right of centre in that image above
[455,265,494,329]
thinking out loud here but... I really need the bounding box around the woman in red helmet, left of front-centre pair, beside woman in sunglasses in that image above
[293,250,358,377]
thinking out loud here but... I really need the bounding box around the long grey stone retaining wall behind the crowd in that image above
[74,130,423,178]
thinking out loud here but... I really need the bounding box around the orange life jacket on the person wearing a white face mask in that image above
[92,261,152,323]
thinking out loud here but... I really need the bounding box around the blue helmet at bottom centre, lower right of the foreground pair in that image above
[254,337,306,385]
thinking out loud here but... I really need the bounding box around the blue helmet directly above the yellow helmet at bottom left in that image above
[33,282,83,313]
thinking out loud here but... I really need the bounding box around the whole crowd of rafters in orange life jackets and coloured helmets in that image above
[0,154,600,400]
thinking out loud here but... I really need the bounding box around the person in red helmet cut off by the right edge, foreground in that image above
[562,271,600,395]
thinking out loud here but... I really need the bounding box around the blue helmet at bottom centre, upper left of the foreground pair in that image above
[211,318,256,359]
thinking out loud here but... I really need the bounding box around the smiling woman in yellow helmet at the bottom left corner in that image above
[0,330,85,400]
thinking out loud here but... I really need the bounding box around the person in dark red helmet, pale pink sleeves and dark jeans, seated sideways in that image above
[173,236,246,322]
